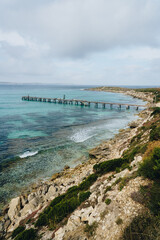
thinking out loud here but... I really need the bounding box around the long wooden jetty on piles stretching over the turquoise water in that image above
[22,96,145,110]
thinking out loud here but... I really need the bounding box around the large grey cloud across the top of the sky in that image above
[0,0,160,57]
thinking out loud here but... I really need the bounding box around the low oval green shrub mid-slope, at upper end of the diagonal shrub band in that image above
[93,158,125,174]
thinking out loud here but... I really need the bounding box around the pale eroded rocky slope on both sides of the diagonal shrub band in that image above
[0,106,152,240]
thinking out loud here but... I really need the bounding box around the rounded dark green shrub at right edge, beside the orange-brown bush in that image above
[139,147,160,179]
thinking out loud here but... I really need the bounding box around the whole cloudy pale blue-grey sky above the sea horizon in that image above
[0,0,160,86]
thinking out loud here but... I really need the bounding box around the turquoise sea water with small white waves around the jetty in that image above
[0,84,144,208]
